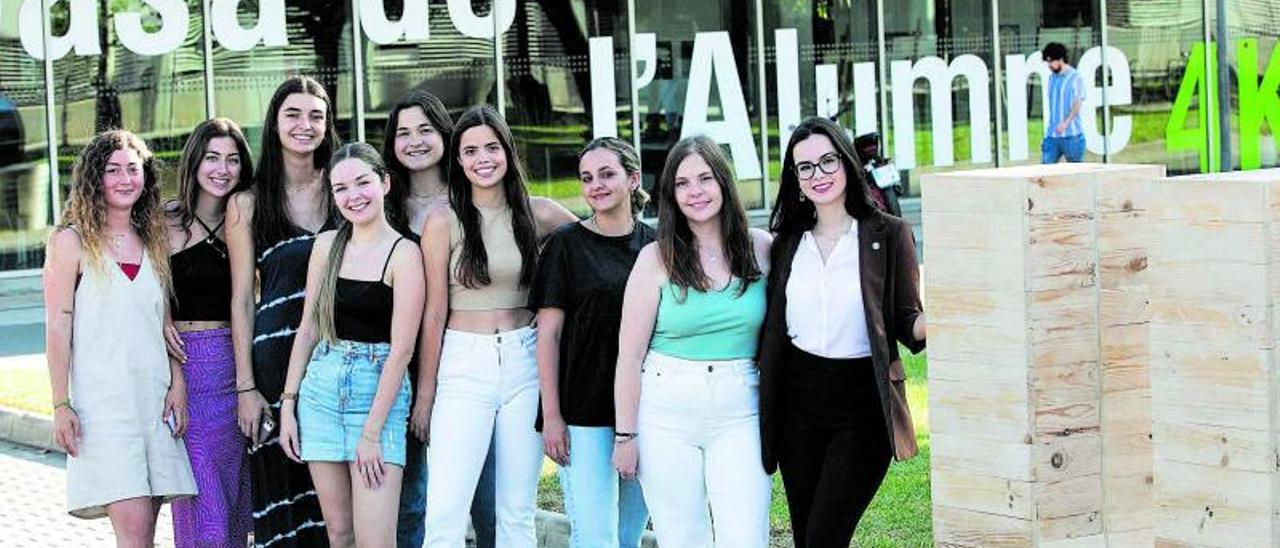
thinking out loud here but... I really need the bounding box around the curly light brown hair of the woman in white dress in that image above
[59,129,173,293]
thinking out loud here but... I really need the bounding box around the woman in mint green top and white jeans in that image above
[613,137,771,548]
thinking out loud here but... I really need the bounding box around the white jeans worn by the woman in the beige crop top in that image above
[424,328,543,548]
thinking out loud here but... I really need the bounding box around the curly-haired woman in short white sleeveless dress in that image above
[45,131,196,547]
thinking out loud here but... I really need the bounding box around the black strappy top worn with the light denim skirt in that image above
[333,238,404,343]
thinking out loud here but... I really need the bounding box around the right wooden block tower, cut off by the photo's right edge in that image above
[1157,169,1280,547]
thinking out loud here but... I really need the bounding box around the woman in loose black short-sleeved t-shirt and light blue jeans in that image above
[529,137,655,548]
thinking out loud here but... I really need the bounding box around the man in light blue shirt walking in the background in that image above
[1041,42,1084,164]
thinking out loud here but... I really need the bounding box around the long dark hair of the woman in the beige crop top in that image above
[449,105,538,289]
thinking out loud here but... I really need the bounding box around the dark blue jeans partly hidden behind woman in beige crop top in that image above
[396,434,498,548]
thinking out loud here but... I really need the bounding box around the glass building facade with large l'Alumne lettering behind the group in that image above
[0,0,1280,274]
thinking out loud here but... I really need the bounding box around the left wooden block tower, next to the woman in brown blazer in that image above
[923,164,1164,547]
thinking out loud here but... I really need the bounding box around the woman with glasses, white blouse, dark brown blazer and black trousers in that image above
[759,118,924,548]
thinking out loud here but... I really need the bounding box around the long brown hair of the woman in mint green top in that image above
[658,136,760,298]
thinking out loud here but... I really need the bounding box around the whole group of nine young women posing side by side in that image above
[45,77,925,547]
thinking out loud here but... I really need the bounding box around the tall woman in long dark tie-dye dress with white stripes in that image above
[227,77,338,548]
